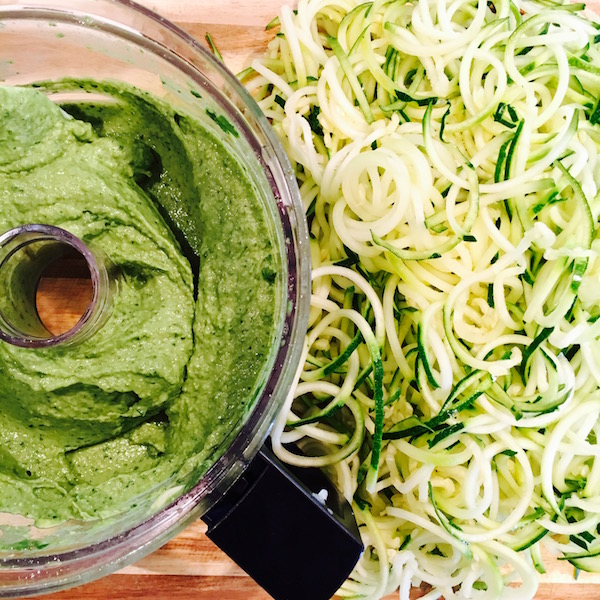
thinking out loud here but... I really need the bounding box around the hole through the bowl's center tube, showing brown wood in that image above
[36,250,94,335]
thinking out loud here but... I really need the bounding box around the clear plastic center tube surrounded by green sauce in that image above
[0,224,114,348]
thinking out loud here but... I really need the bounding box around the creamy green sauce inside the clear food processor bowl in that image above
[0,82,281,525]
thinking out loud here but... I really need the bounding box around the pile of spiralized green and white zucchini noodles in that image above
[245,0,600,600]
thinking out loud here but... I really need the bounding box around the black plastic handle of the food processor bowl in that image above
[203,446,364,600]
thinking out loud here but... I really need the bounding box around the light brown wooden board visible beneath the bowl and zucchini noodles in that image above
[36,0,600,600]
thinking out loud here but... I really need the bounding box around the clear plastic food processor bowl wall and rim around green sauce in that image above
[0,0,310,597]
